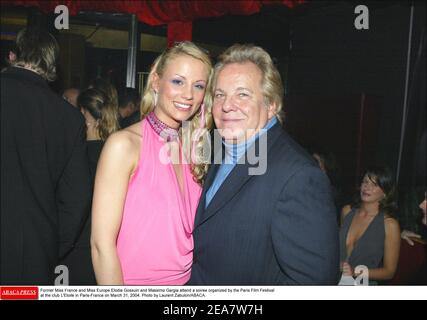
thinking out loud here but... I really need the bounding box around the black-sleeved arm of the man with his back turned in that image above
[56,123,92,258]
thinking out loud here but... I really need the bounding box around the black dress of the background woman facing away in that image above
[62,140,104,285]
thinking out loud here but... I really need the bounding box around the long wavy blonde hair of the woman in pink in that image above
[141,41,213,184]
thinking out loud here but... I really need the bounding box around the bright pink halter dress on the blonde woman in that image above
[117,118,201,285]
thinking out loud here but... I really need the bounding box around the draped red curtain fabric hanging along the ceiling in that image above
[2,0,305,44]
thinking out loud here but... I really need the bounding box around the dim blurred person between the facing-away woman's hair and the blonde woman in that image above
[119,88,141,129]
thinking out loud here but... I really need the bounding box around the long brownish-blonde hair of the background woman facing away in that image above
[77,88,119,141]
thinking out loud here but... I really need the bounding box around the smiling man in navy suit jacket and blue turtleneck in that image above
[189,45,339,285]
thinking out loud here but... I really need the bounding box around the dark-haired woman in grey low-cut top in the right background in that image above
[340,167,400,284]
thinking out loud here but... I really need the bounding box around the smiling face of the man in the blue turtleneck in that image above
[212,62,274,143]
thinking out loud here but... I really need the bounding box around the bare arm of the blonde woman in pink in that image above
[91,131,139,285]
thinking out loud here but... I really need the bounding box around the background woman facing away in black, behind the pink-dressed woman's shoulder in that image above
[62,88,119,285]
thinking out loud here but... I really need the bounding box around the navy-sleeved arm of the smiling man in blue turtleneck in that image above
[271,166,339,285]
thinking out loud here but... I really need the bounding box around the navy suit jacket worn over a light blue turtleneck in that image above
[189,124,339,285]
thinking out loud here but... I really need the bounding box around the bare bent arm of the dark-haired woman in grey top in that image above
[369,218,400,280]
